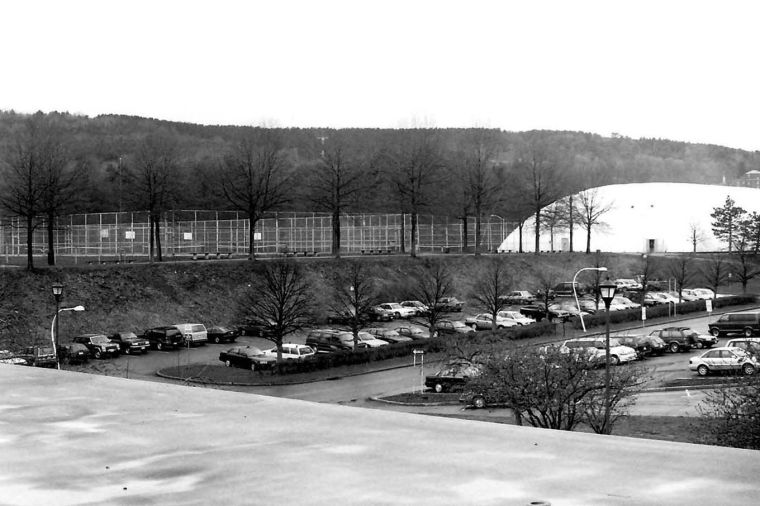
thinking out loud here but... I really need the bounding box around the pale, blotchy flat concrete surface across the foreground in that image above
[0,365,760,506]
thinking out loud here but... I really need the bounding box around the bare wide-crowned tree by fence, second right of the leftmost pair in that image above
[220,128,292,260]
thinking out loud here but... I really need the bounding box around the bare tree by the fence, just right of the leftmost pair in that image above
[125,130,179,262]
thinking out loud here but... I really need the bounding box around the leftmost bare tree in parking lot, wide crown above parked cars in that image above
[239,261,314,362]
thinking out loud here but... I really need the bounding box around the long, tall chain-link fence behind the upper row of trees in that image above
[0,211,517,260]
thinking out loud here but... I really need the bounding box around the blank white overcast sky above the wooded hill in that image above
[0,0,760,150]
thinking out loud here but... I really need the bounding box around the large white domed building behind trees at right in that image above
[499,183,760,253]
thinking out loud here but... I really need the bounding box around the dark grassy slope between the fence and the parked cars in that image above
[0,253,688,349]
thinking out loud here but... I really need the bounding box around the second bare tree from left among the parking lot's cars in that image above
[330,261,377,350]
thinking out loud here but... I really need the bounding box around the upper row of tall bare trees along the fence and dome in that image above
[0,113,624,269]
